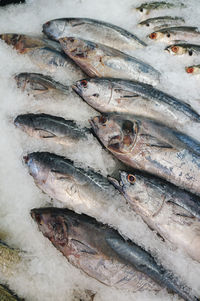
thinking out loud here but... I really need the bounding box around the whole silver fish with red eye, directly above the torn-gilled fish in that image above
[72,78,200,134]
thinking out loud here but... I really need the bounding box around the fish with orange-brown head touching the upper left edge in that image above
[0,33,83,77]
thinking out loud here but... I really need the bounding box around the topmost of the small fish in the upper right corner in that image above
[136,1,185,15]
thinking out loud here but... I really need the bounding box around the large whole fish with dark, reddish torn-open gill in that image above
[91,115,200,195]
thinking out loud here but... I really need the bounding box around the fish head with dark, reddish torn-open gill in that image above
[90,115,138,154]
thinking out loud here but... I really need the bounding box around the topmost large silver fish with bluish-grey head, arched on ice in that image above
[43,18,146,54]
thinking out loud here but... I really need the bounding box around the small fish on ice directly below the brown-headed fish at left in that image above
[14,72,70,100]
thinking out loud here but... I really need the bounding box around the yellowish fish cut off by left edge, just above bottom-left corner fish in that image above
[0,240,21,275]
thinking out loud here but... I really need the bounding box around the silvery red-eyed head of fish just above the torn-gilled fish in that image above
[72,78,112,111]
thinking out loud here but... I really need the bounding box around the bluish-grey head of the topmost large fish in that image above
[43,19,66,40]
